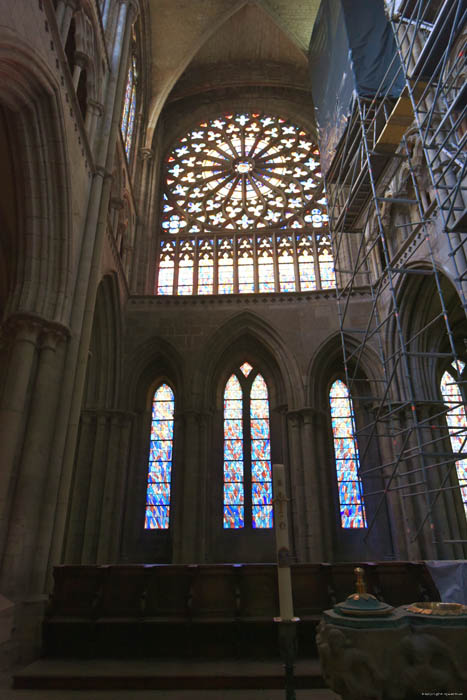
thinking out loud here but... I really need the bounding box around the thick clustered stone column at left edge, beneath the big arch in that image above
[0,314,69,598]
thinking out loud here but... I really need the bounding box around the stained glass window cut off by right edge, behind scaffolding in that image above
[441,361,467,517]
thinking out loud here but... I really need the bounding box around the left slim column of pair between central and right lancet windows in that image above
[287,411,308,561]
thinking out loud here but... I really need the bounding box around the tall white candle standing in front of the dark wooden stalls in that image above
[272,464,294,620]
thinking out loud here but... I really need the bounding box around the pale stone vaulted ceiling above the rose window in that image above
[148,0,320,139]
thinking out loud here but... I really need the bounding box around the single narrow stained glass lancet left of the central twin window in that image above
[144,384,174,530]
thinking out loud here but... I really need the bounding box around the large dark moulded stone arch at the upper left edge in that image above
[0,34,72,322]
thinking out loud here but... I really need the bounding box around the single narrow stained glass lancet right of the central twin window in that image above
[329,379,366,528]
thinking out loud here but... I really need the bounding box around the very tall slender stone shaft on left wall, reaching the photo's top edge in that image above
[48,0,138,584]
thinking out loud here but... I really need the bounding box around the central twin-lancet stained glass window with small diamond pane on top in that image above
[223,362,273,529]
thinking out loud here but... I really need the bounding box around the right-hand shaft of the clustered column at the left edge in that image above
[2,322,68,597]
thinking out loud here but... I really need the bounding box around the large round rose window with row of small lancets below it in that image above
[155,112,336,294]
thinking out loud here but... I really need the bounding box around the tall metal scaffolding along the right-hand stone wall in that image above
[325,0,467,558]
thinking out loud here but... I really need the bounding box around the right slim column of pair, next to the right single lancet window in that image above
[301,407,325,561]
